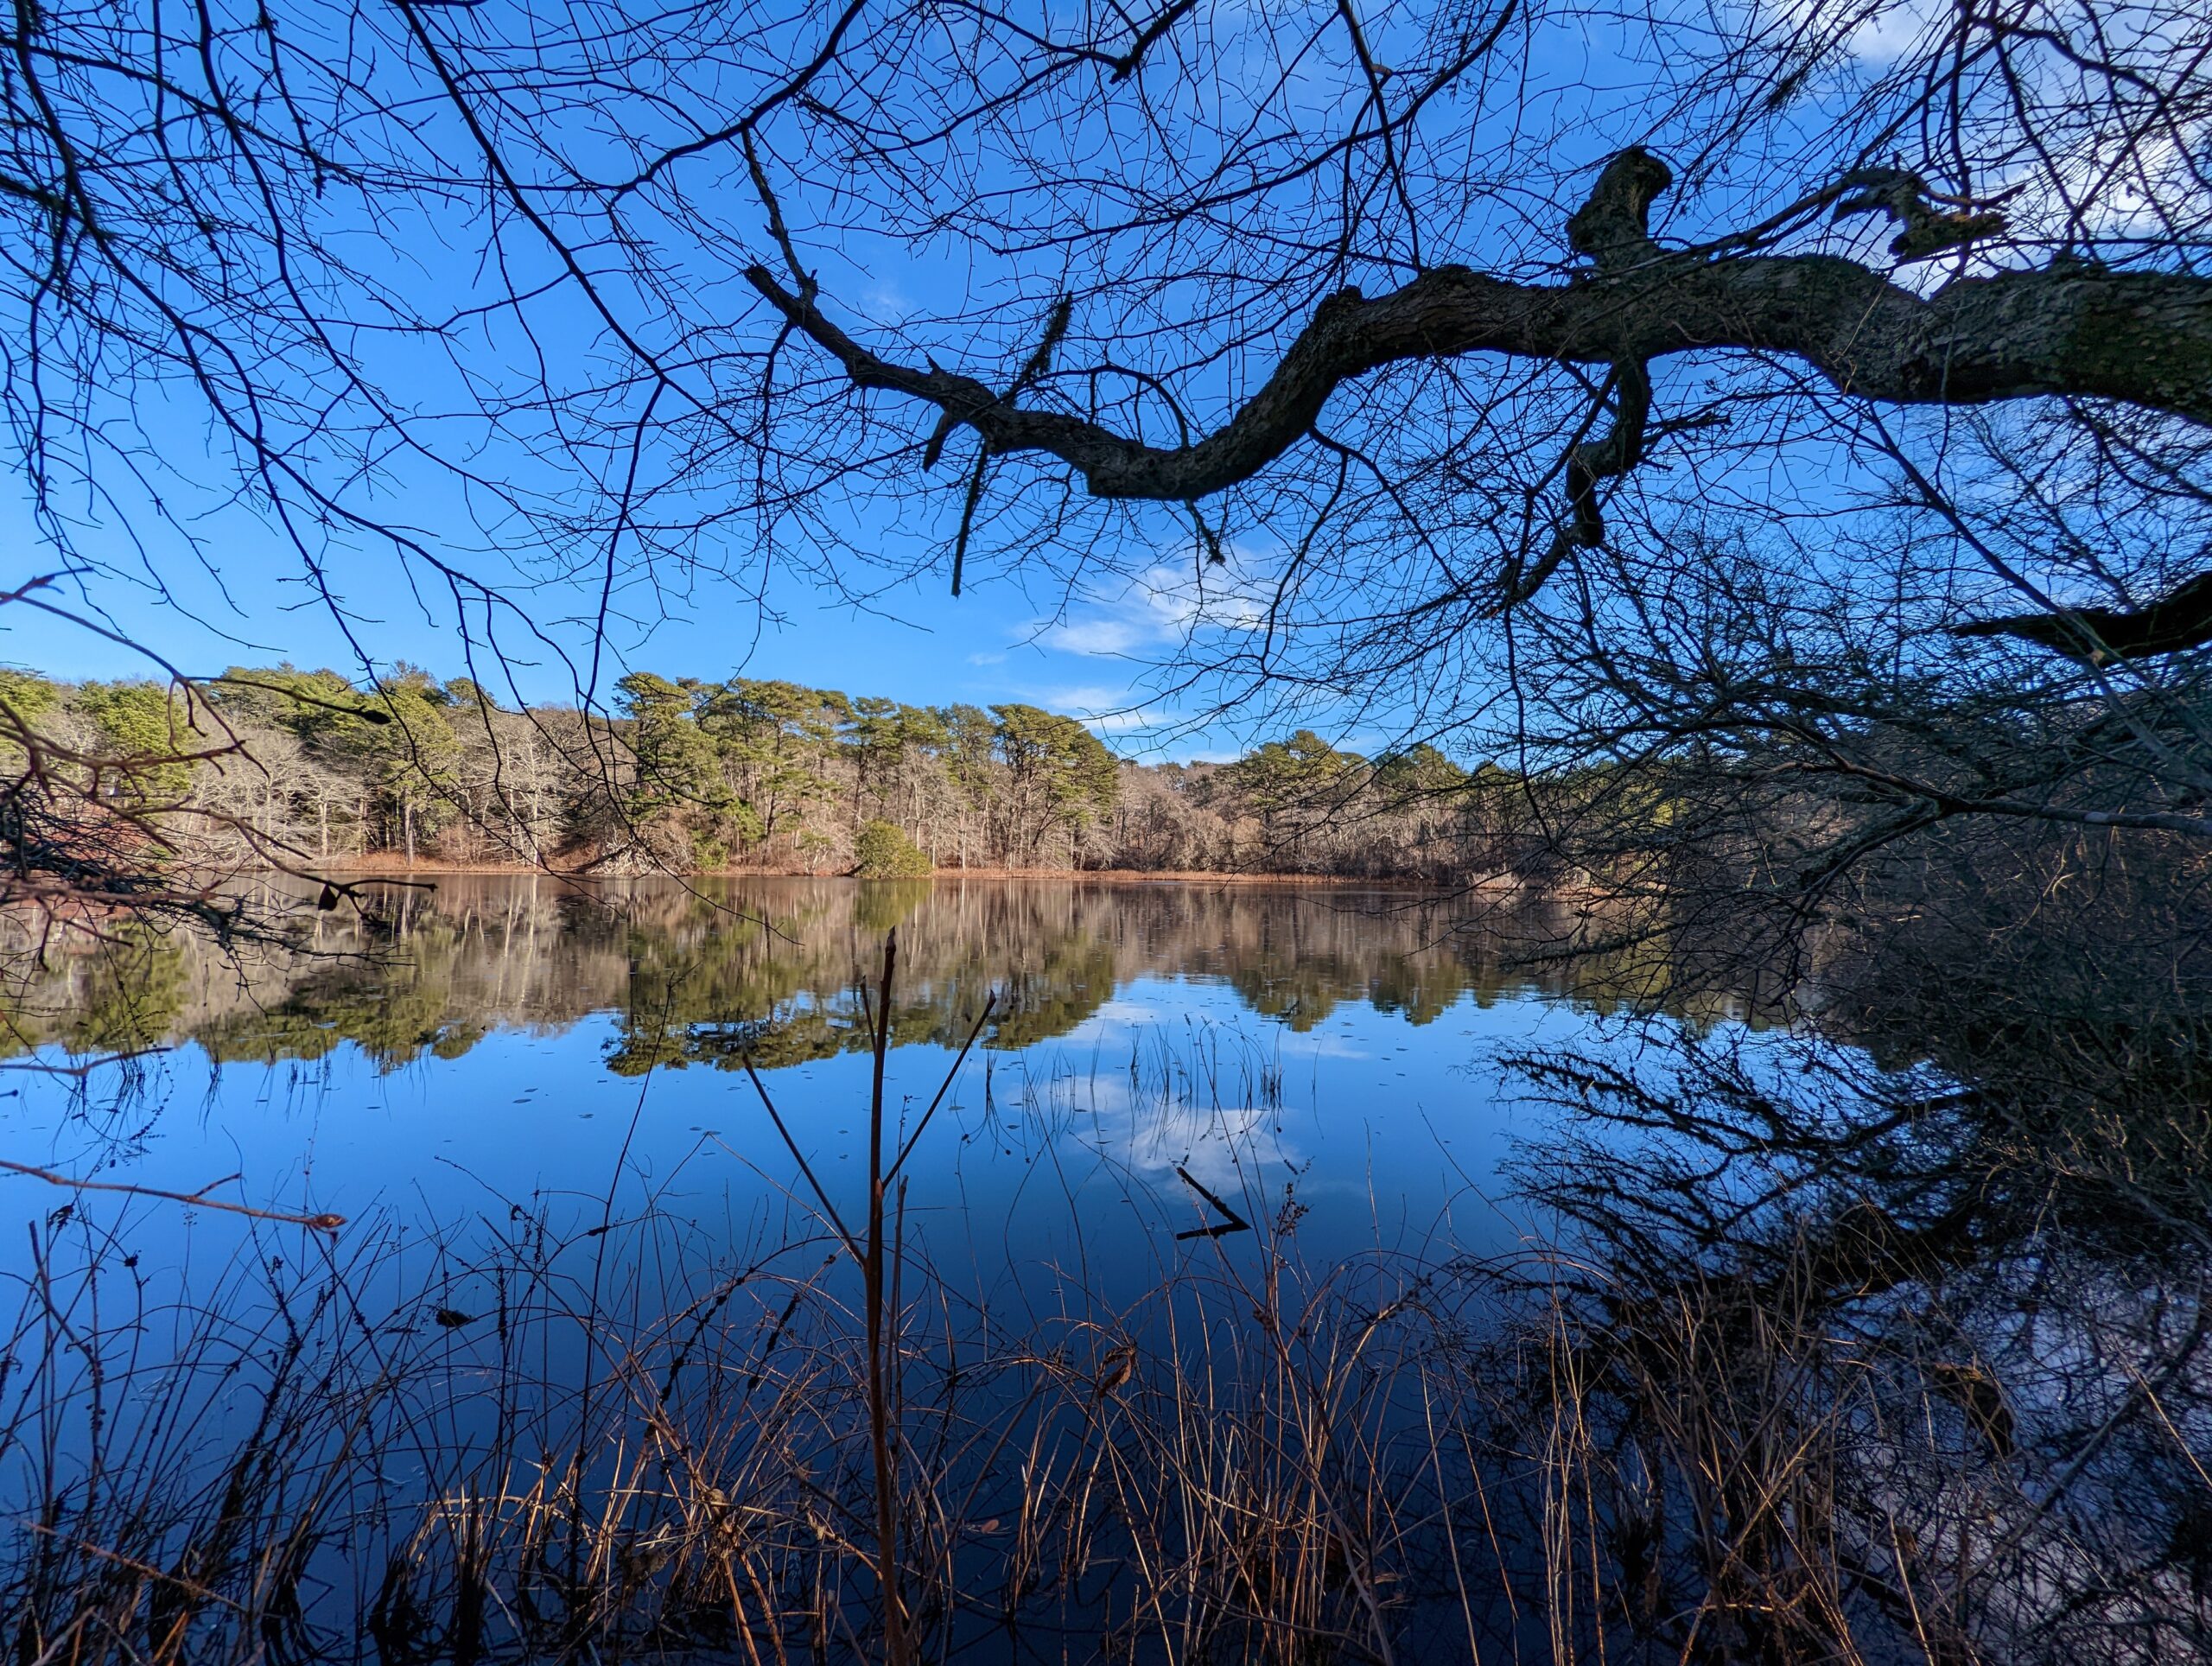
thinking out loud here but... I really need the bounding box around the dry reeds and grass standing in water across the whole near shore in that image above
[0,938,2212,1666]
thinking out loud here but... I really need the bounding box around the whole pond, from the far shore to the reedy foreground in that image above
[0,876,2185,1666]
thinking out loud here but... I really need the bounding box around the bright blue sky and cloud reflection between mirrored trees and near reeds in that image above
[4,978,1595,1309]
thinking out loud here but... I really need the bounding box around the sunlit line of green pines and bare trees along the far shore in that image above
[0,664,1516,881]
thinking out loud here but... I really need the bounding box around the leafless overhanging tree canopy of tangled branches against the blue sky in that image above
[0,0,2212,871]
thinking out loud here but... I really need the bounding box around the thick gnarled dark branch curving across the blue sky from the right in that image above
[747,150,2212,502]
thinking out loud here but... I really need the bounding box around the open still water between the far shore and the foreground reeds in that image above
[7,876,1707,1279]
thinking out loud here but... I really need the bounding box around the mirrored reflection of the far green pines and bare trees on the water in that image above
[0,876,1751,1071]
